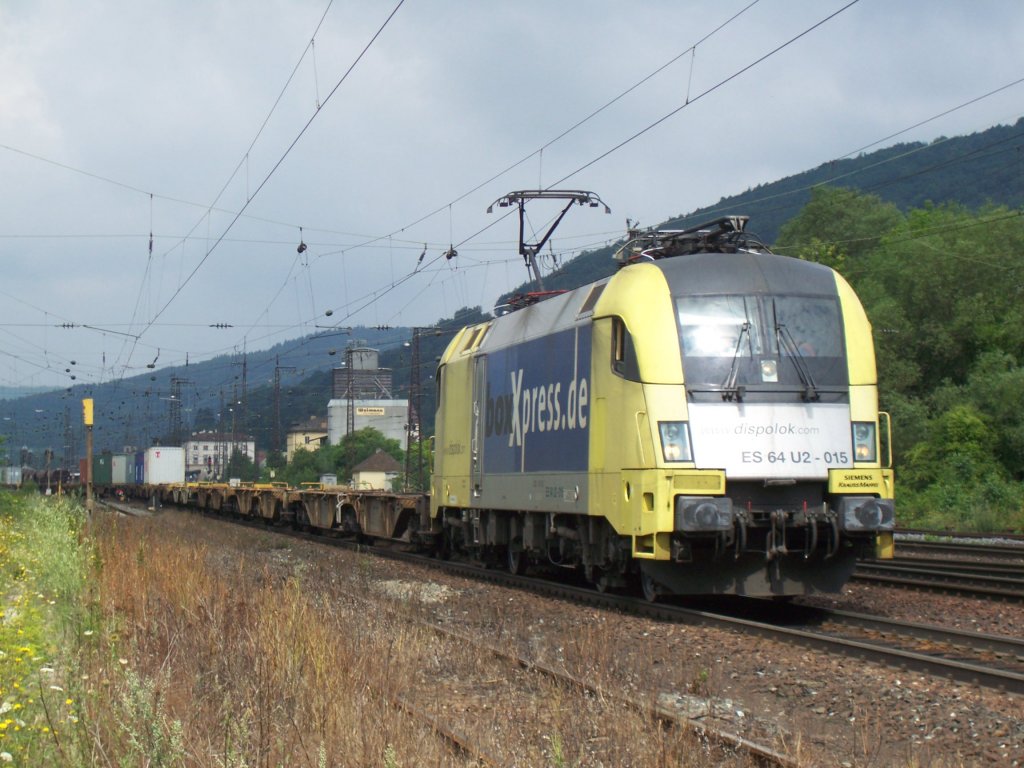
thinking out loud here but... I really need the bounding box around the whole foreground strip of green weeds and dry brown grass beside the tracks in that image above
[14,495,983,768]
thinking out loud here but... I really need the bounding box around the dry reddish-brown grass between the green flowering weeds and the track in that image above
[74,513,770,768]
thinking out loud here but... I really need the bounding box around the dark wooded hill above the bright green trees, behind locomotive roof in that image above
[502,118,1024,301]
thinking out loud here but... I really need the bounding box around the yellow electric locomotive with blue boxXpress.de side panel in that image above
[430,216,894,600]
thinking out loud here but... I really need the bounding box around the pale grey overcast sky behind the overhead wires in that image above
[0,0,1024,387]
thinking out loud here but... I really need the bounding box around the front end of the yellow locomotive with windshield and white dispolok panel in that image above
[610,219,894,595]
